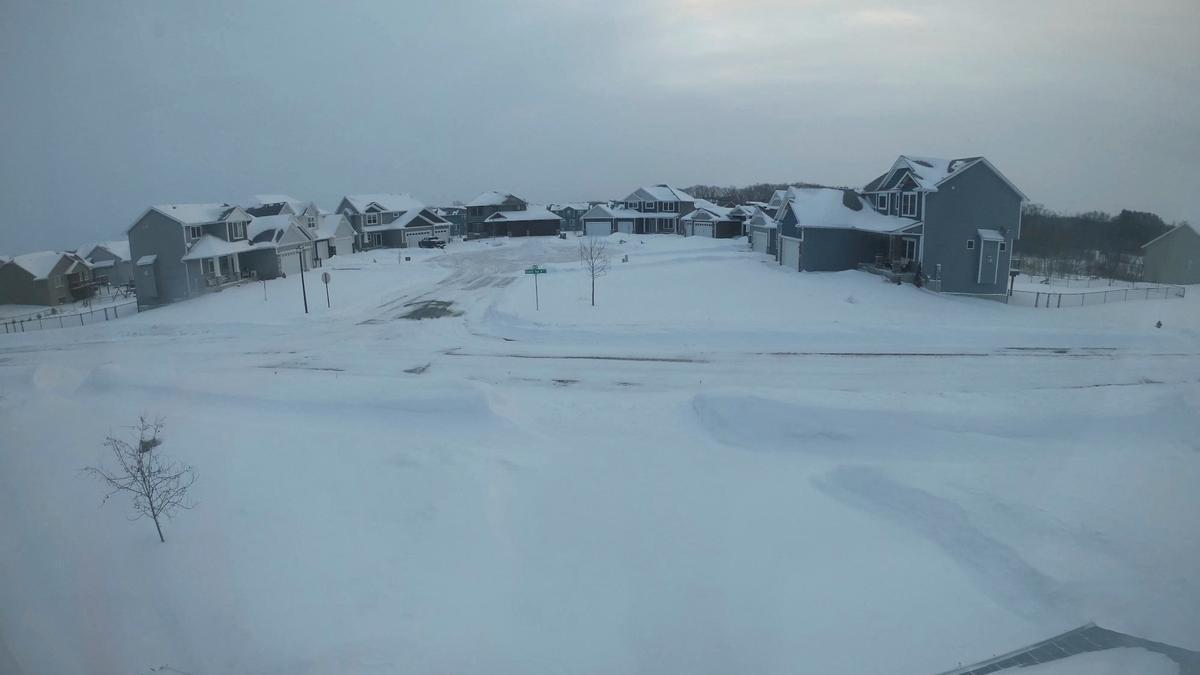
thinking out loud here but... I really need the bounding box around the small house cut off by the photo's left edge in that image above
[0,251,95,306]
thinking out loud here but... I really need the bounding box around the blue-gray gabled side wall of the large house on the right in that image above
[922,162,1021,295]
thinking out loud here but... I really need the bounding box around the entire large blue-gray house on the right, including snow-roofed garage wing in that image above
[773,155,1026,297]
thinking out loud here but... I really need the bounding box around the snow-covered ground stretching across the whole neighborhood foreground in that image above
[0,235,1200,675]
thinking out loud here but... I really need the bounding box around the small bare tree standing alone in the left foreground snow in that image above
[83,416,196,543]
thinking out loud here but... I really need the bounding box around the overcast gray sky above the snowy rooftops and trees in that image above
[0,0,1200,255]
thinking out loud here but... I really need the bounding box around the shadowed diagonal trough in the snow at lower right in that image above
[812,466,1081,622]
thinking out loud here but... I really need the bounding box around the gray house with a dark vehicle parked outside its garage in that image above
[337,193,450,250]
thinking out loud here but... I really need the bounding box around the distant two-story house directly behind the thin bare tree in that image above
[581,184,700,237]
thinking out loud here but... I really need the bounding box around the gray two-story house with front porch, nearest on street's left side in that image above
[126,203,253,307]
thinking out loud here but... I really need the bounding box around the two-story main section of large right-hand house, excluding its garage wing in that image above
[863,155,1027,295]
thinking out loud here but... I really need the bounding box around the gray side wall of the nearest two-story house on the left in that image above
[128,210,188,306]
